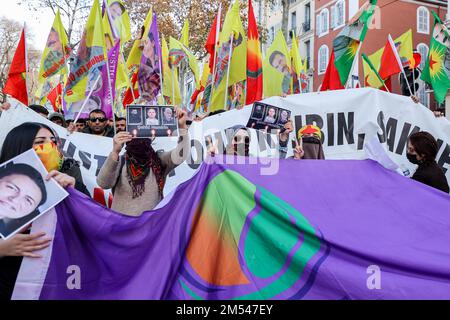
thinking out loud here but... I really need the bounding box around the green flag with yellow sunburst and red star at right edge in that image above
[421,11,450,103]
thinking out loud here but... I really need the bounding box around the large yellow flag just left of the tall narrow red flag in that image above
[211,0,247,111]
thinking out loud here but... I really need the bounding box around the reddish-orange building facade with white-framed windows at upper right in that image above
[313,0,447,110]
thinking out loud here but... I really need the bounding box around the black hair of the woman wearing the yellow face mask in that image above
[0,122,58,163]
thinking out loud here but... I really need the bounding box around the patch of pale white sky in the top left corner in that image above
[0,0,54,51]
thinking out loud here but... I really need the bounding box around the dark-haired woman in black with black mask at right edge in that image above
[406,131,450,193]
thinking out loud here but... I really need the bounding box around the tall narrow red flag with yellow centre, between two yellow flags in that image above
[246,0,263,105]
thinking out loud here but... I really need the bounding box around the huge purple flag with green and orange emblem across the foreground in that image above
[10,158,450,300]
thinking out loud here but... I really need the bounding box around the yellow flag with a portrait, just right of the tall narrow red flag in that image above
[263,30,291,98]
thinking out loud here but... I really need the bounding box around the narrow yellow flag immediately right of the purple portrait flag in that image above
[161,37,181,105]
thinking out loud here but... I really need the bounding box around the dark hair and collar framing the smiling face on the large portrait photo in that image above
[0,163,47,236]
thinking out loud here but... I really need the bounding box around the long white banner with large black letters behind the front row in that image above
[0,88,450,199]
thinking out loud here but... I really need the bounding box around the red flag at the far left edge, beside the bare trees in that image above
[3,28,28,106]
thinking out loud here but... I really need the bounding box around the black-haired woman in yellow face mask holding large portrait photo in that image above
[0,122,85,300]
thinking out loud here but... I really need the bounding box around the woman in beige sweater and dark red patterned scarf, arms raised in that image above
[97,109,190,216]
